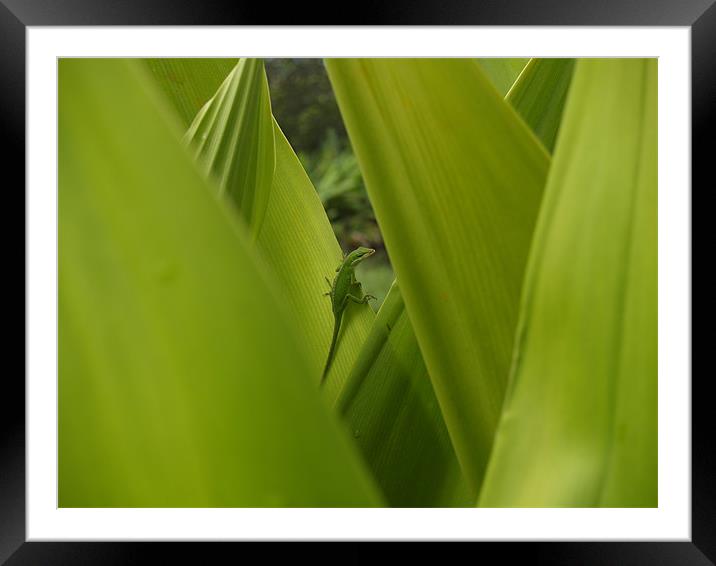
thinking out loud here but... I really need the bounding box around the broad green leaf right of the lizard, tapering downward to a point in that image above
[327,55,549,491]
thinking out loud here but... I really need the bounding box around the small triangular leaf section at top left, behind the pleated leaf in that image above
[140,58,239,128]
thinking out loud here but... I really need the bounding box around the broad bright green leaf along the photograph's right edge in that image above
[480,59,657,507]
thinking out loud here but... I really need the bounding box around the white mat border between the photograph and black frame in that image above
[27,27,691,540]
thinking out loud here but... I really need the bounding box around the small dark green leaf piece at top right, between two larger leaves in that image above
[506,59,574,153]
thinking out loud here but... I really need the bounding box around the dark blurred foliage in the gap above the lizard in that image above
[266,59,394,308]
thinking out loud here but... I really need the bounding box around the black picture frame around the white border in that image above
[0,0,704,566]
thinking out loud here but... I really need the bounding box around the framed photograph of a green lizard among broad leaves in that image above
[58,56,656,509]
